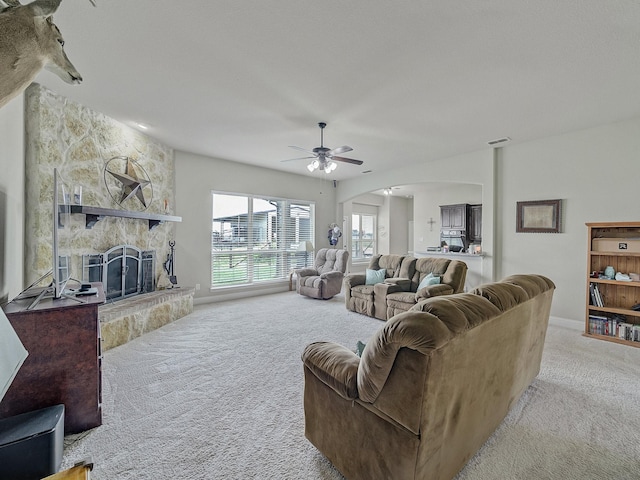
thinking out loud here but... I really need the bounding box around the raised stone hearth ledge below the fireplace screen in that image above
[98,287,195,351]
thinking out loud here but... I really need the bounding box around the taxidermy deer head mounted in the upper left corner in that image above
[0,0,95,108]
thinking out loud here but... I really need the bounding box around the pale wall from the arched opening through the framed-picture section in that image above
[338,118,640,322]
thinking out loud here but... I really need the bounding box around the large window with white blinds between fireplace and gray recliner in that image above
[211,192,315,287]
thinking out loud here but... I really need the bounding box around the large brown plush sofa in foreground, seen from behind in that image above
[302,275,555,480]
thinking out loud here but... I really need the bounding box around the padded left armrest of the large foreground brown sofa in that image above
[302,342,360,400]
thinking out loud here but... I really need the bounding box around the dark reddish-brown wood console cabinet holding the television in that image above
[0,283,105,435]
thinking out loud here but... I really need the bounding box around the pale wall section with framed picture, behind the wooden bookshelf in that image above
[498,118,640,321]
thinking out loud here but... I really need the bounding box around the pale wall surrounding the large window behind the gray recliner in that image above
[175,151,342,303]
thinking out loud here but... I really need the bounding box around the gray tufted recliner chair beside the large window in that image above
[295,248,349,300]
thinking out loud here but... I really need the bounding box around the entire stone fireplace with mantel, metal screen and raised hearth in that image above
[25,83,194,350]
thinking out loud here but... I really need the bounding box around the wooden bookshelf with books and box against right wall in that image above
[584,222,640,348]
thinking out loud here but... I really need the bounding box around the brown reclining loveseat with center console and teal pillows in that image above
[343,255,467,320]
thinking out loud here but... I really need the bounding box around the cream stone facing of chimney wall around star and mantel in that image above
[25,84,176,288]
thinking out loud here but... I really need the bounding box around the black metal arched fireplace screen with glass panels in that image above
[82,245,155,301]
